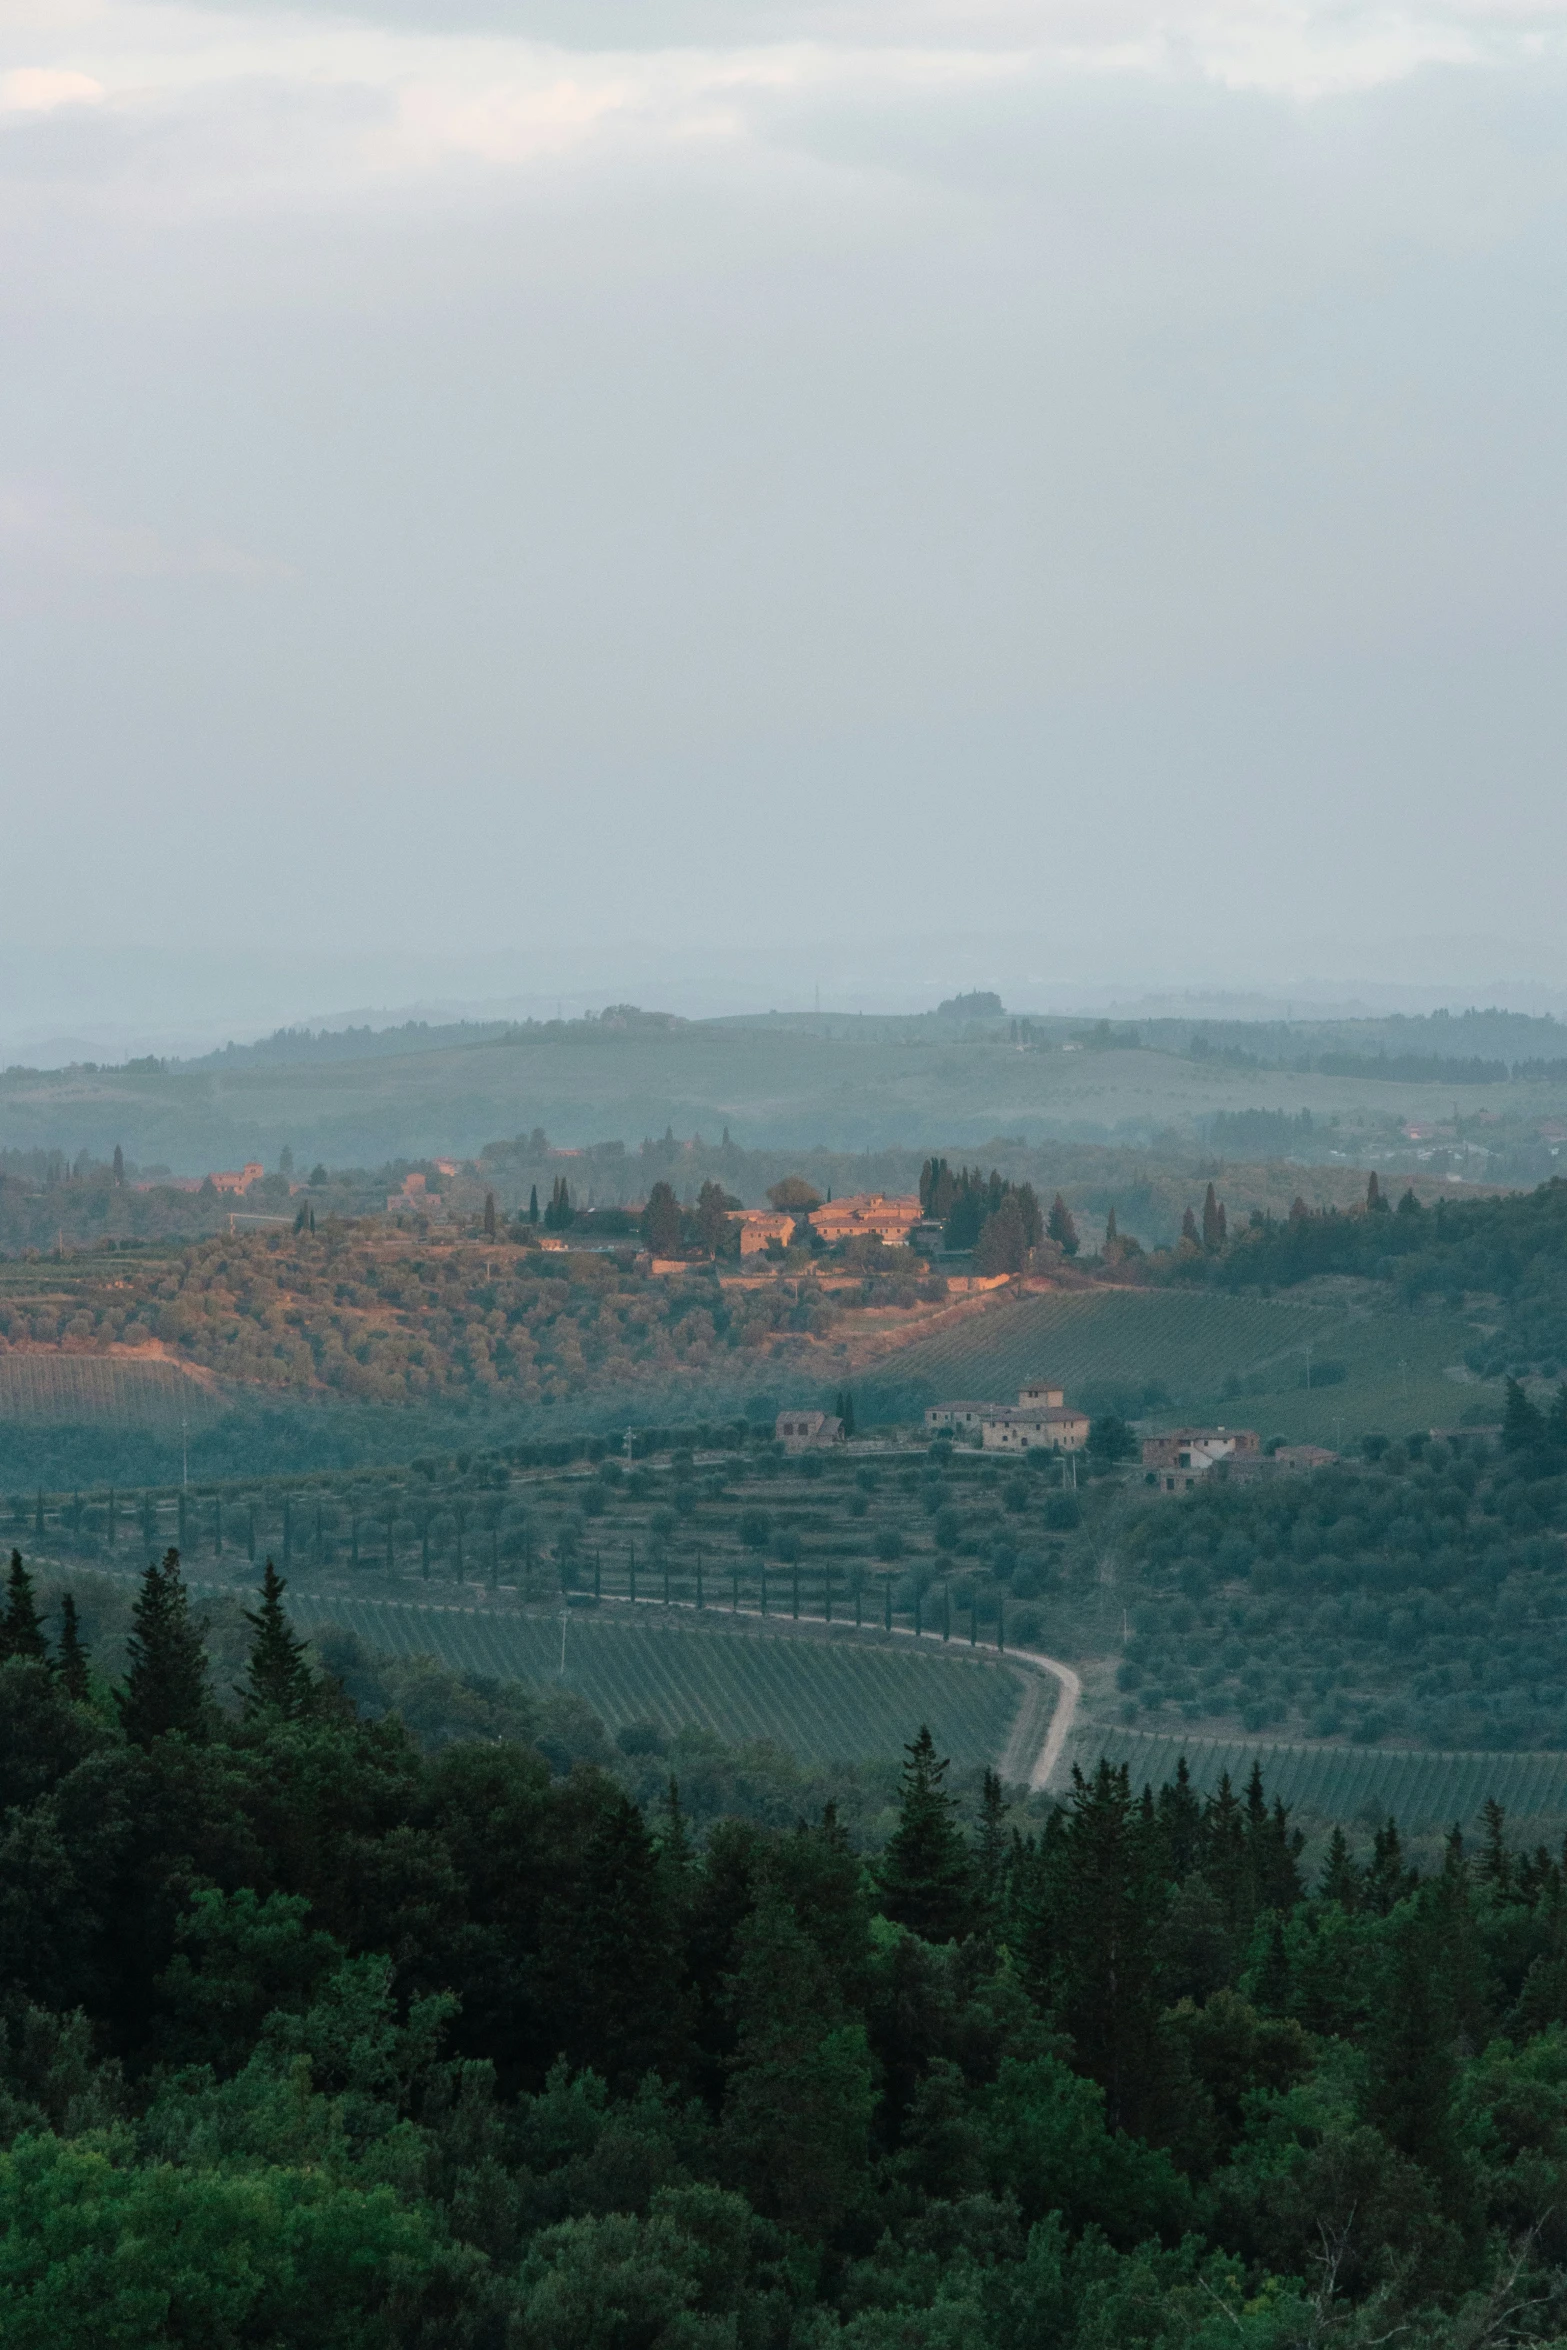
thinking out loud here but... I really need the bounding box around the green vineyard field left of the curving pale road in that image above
[312,1600,1024,1765]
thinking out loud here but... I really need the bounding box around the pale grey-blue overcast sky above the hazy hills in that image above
[0,0,1567,1041]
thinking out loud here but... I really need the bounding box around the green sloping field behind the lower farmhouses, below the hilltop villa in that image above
[865,1290,1501,1445]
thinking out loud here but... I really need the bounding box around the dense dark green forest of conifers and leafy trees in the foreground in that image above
[0,1551,1567,2350]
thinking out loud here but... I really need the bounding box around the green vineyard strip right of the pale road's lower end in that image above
[1071,1727,1567,1831]
